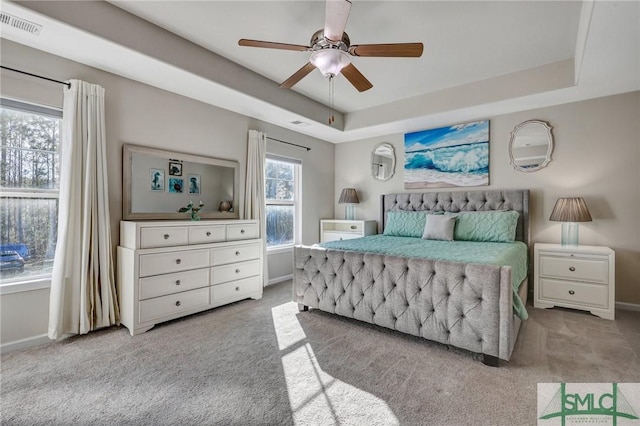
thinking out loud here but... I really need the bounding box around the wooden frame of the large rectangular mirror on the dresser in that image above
[122,144,240,220]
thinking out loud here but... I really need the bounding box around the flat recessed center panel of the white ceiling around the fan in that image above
[111,0,581,112]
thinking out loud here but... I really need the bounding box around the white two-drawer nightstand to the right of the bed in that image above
[533,244,615,320]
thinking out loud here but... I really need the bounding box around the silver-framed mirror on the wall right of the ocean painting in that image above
[509,120,553,172]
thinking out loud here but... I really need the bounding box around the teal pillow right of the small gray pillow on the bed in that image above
[453,210,520,243]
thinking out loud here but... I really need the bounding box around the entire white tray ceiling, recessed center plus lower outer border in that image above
[0,0,640,142]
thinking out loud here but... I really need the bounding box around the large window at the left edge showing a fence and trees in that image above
[0,99,62,283]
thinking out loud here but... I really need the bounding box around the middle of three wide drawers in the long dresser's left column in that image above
[138,268,209,300]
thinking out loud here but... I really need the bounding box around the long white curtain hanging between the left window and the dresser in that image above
[49,80,120,339]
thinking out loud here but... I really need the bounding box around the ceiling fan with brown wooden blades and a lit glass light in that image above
[238,0,423,92]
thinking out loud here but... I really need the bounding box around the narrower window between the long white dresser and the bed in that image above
[265,155,301,249]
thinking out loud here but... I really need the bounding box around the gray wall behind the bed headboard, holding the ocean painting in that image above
[334,92,640,304]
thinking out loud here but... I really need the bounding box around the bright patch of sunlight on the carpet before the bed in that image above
[271,302,400,424]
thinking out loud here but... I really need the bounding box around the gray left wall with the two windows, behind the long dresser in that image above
[0,39,335,344]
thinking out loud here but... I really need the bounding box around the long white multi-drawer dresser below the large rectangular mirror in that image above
[118,220,264,336]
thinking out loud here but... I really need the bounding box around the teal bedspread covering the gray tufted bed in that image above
[320,235,528,320]
